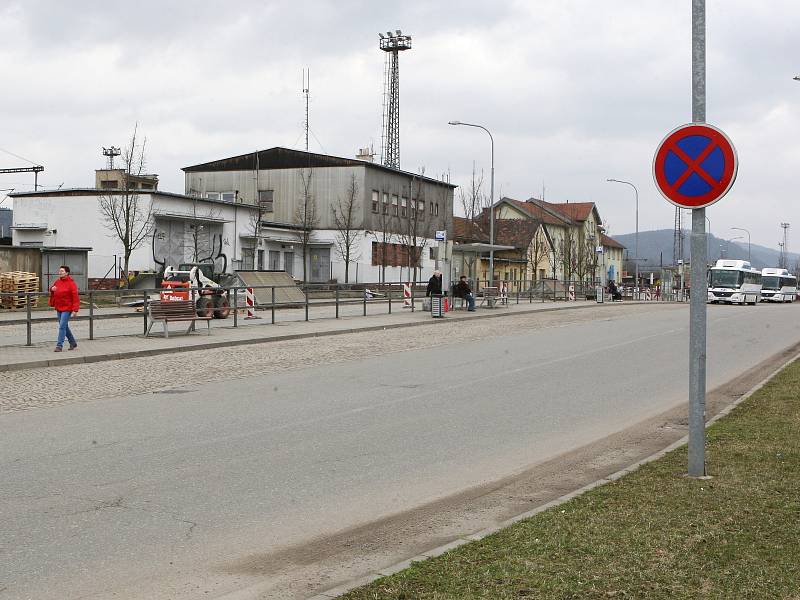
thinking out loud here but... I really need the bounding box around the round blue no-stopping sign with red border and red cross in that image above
[653,123,739,208]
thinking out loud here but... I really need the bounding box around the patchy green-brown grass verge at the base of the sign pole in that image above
[342,362,800,600]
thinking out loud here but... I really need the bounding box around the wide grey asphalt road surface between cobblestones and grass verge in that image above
[0,305,800,600]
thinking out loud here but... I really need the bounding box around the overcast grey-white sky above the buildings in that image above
[0,0,800,251]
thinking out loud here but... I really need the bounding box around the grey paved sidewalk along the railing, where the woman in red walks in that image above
[0,302,620,372]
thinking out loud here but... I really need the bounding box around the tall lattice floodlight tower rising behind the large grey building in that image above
[378,29,411,169]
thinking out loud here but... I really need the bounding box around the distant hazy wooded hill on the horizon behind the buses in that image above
[613,229,800,269]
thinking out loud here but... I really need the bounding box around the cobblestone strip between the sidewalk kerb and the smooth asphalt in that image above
[0,304,668,414]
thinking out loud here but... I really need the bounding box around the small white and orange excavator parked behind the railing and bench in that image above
[161,263,231,319]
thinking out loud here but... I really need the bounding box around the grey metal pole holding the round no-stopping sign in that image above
[688,0,708,477]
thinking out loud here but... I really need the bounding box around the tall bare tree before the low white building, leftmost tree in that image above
[100,124,153,285]
